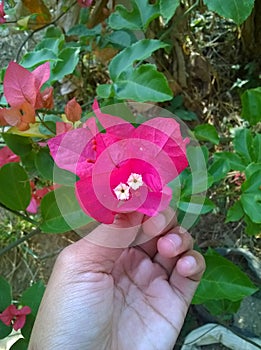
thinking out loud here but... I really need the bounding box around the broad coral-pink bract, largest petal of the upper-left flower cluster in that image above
[4,62,37,108]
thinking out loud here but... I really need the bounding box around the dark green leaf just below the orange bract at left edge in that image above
[2,133,33,156]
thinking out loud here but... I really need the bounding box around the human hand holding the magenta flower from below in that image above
[29,209,205,350]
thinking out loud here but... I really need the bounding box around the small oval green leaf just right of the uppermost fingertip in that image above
[178,195,216,215]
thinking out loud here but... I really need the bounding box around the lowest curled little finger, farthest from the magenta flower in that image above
[169,250,206,304]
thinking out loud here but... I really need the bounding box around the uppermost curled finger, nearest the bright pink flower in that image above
[136,208,177,258]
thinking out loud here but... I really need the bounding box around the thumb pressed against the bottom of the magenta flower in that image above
[58,212,144,273]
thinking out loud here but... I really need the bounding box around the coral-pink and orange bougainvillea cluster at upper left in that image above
[0,62,53,130]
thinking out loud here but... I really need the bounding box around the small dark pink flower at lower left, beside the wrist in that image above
[0,305,31,331]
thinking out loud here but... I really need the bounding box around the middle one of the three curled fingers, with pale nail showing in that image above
[153,226,193,276]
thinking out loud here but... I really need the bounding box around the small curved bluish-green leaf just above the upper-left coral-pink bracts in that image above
[21,48,57,68]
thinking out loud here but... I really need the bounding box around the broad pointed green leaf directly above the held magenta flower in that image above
[114,64,172,102]
